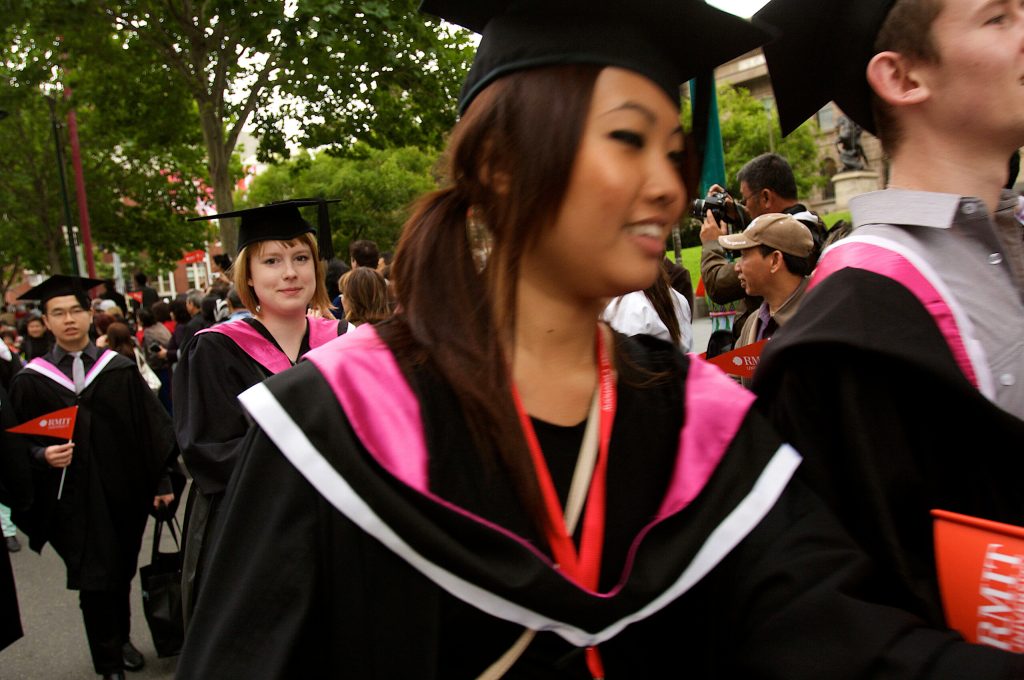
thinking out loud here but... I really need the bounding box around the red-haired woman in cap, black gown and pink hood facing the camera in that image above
[173,201,345,615]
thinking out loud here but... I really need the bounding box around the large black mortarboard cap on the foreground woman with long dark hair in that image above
[420,0,770,112]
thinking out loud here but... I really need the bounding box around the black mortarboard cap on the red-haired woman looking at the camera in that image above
[188,199,340,260]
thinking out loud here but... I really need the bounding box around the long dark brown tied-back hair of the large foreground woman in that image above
[385,66,601,520]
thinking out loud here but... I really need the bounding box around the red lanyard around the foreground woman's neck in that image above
[512,327,617,678]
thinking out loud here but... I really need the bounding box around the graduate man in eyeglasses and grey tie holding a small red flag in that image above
[10,274,176,678]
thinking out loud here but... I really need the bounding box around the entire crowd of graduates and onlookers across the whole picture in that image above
[0,0,1024,679]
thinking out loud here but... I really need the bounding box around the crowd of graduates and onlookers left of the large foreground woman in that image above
[0,232,393,678]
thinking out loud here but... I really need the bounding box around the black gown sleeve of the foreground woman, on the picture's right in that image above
[718,480,1024,680]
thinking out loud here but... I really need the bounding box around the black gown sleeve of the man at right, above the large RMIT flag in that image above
[759,347,1024,626]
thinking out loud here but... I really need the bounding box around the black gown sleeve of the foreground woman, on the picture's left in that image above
[177,429,321,678]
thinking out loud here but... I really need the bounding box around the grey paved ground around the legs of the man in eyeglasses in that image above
[0,504,184,680]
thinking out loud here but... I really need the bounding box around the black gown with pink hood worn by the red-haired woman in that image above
[172,317,347,608]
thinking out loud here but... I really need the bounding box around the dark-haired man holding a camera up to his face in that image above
[694,154,824,338]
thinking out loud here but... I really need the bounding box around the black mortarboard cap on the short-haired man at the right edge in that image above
[754,0,895,134]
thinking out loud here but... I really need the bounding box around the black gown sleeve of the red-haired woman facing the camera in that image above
[173,333,265,495]
